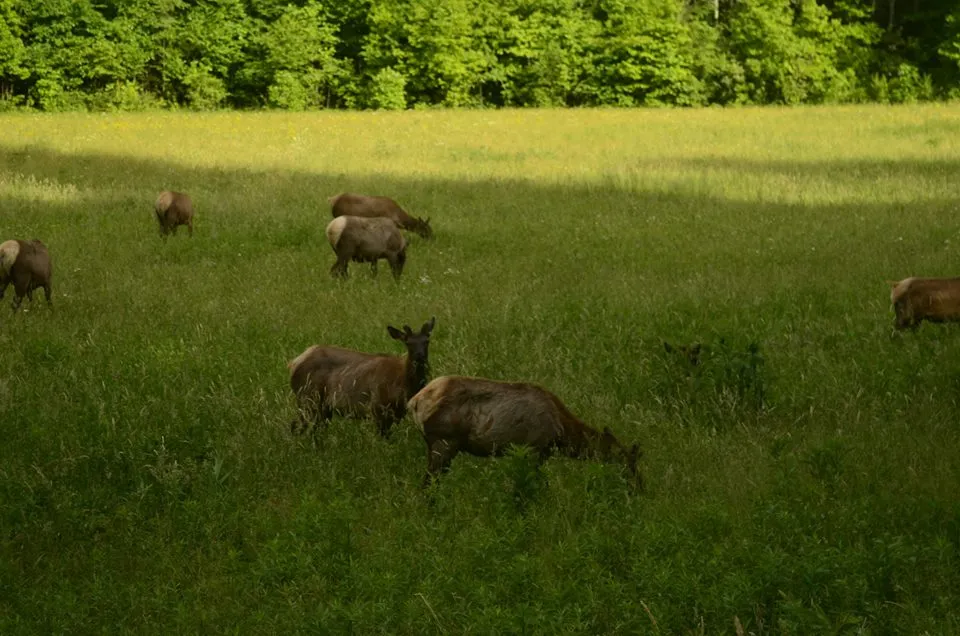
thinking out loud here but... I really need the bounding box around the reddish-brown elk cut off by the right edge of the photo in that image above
[890,278,960,329]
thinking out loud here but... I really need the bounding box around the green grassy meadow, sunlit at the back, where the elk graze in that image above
[0,105,960,634]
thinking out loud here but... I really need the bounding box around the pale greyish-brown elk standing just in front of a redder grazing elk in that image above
[327,216,407,279]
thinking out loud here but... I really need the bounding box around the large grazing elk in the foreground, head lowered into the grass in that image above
[407,376,643,489]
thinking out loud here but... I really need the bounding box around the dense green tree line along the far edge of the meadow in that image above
[0,0,960,110]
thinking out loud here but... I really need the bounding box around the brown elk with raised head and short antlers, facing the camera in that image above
[287,318,436,437]
